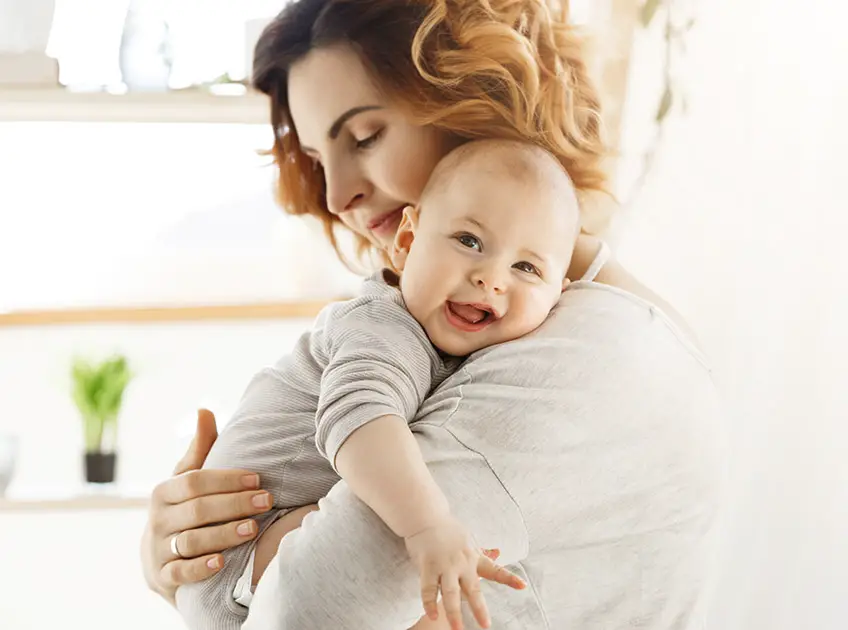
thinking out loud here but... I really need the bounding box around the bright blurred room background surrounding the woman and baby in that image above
[0,0,848,630]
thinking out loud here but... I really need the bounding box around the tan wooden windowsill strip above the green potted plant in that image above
[0,298,345,328]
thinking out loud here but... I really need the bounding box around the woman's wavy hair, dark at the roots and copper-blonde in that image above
[253,0,607,262]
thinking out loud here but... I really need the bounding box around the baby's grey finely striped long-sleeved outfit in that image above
[177,271,459,630]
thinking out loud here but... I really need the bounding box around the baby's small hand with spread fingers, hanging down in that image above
[404,516,525,630]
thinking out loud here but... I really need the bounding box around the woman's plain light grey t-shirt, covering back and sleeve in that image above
[244,282,724,630]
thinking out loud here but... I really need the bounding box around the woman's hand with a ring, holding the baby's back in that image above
[141,409,271,605]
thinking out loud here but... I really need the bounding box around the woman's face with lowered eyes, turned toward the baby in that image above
[288,47,456,249]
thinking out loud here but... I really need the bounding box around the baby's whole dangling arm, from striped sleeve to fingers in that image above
[316,301,520,627]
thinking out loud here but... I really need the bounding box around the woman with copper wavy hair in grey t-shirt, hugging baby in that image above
[142,0,720,630]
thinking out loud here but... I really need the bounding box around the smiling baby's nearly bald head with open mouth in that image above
[391,140,580,356]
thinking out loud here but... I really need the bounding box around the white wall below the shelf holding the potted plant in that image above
[0,510,185,630]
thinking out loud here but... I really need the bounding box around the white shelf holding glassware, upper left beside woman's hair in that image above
[0,88,270,124]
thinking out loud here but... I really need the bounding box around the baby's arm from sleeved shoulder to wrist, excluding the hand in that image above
[316,299,449,537]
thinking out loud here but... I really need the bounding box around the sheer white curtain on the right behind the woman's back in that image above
[618,0,848,630]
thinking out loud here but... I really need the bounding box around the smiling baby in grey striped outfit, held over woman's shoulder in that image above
[177,140,579,628]
